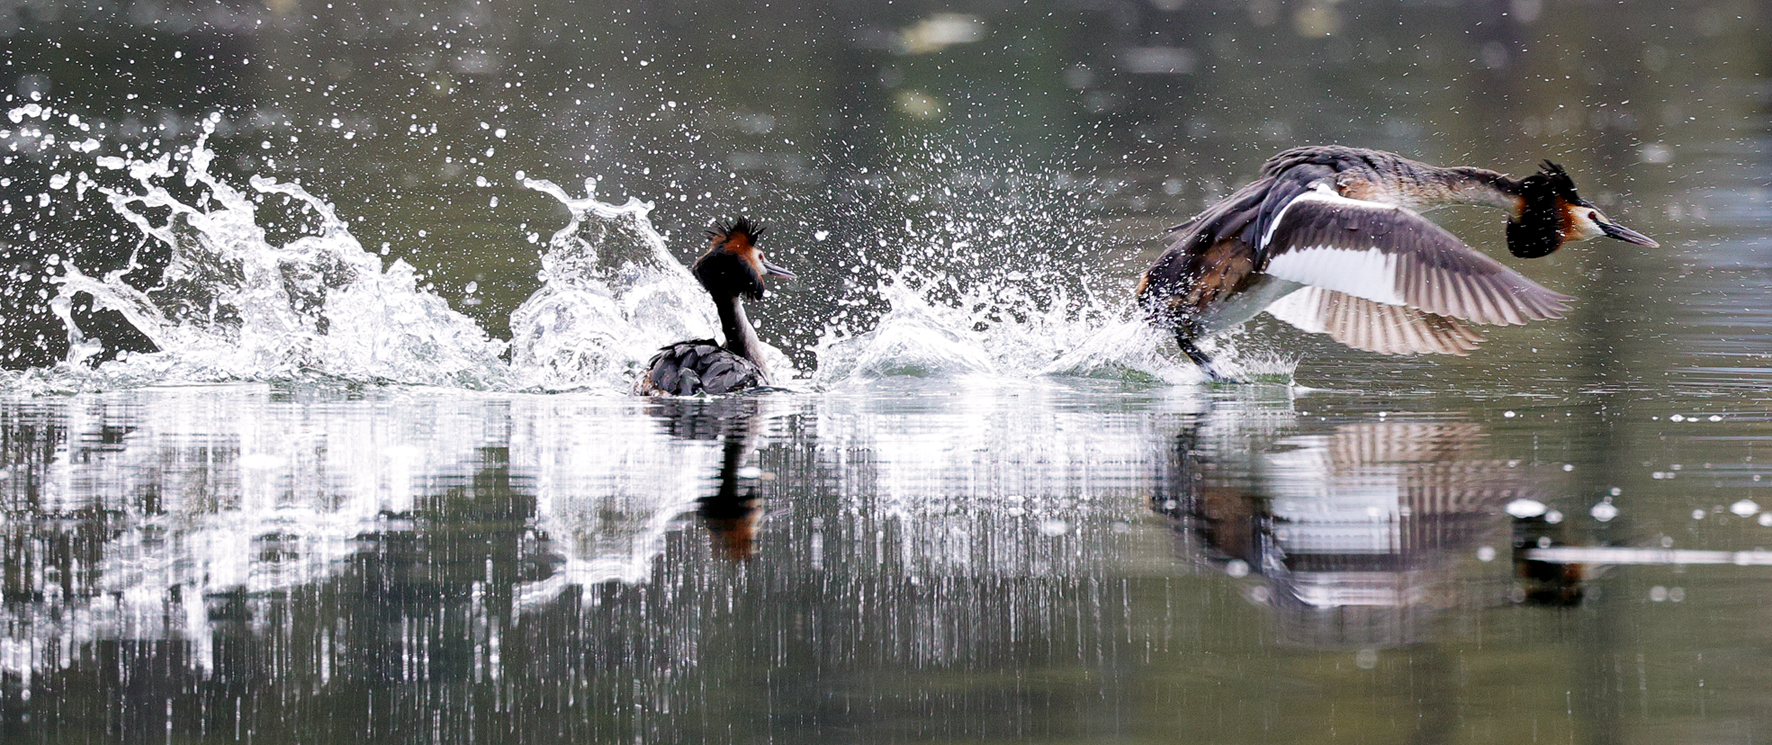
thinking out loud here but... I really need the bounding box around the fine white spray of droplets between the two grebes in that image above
[797,142,1226,388]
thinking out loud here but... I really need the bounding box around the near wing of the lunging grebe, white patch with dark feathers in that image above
[1260,186,1574,325]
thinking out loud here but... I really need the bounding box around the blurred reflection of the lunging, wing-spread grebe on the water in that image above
[1152,415,1579,646]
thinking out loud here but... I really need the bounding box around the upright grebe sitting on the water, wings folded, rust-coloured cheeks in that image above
[634,218,794,396]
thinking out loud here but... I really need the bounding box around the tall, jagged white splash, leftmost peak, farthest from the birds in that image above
[53,117,509,388]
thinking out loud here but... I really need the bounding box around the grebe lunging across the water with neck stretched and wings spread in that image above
[1138,145,1657,380]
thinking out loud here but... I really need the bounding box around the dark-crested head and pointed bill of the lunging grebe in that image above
[1508,160,1659,259]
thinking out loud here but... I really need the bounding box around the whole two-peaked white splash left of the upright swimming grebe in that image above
[12,105,794,392]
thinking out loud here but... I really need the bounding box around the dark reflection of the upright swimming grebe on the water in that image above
[652,396,766,561]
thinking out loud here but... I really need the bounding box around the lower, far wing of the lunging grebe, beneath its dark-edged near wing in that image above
[1267,287,1483,357]
